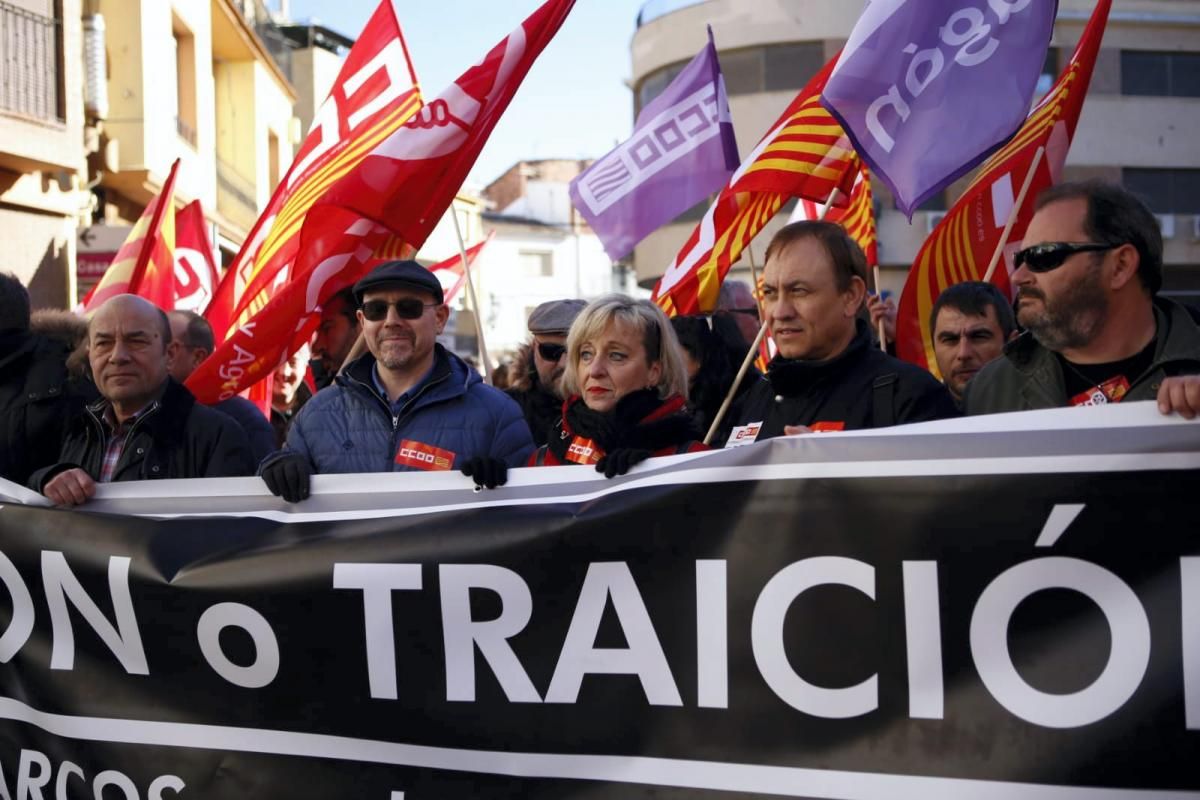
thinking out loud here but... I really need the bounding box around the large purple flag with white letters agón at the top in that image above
[821,0,1058,219]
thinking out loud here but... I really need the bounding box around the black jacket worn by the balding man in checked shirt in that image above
[28,379,254,492]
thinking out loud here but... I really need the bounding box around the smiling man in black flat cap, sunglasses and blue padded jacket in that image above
[259,260,533,503]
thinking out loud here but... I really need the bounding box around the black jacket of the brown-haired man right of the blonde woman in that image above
[713,320,959,446]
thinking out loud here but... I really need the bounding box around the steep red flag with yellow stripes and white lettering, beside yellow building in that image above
[204,0,421,342]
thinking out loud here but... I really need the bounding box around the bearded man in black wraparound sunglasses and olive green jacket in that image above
[965,181,1200,419]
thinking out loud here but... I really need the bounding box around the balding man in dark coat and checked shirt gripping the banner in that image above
[29,295,254,506]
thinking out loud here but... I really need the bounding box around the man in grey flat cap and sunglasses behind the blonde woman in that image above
[505,300,587,447]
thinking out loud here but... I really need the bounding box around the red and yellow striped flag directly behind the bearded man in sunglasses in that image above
[896,0,1112,377]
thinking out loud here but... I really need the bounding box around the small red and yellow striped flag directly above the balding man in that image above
[83,158,179,314]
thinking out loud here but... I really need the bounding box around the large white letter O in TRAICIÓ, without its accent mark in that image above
[971,557,1150,728]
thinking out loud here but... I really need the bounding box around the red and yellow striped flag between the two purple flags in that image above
[653,56,856,315]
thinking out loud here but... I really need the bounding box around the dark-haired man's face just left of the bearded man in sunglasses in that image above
[926,281,1016,403]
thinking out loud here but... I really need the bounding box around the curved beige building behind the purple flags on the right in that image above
[631,0,1200,300]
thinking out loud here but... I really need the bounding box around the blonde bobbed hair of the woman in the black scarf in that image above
[563,294,688,399]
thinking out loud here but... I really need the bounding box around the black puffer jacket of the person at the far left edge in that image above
[0,332,75,483]
